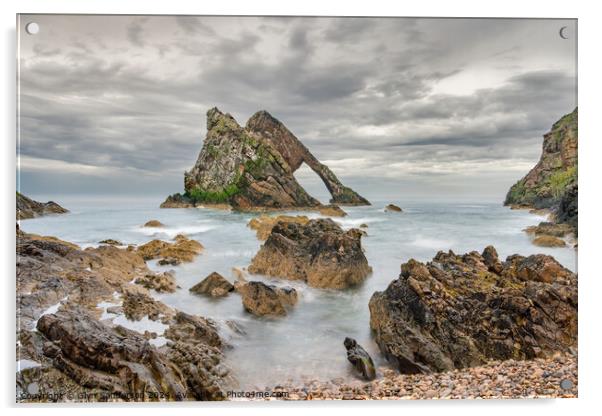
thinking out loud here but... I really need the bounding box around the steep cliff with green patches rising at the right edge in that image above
[505,108,578,228]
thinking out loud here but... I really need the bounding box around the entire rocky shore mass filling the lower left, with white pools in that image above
[17,228,234,402]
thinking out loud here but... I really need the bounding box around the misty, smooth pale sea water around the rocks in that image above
[21,197,577,389]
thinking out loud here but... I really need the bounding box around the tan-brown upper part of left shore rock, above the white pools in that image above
[17,232,151,330]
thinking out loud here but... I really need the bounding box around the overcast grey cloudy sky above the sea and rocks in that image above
[19,15,577,202]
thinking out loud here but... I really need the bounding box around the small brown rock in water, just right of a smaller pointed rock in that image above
[237,281,297,316]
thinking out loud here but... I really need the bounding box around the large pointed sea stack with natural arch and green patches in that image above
[161,107,370,210]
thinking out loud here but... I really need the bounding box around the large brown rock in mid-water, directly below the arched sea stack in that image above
[249,219,372,289]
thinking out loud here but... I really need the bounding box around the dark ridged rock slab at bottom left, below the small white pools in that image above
[38,308,230,401]
